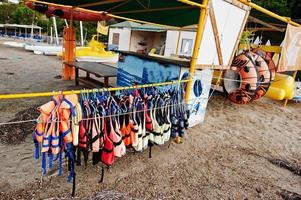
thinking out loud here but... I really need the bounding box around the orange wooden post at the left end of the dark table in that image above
[63,24,76,80]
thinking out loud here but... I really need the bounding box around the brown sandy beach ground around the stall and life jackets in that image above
[0,38,301,199]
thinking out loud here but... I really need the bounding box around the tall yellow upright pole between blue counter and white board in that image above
[186,0,209,104]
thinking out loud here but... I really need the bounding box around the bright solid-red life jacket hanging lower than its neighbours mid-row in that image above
[101,118,115,166]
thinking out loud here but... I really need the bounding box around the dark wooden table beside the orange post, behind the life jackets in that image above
[65,62,117,88]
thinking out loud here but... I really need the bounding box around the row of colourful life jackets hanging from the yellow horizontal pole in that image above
[33,91,189,181]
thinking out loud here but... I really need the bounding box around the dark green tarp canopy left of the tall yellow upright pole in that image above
[29,0,202,27]
